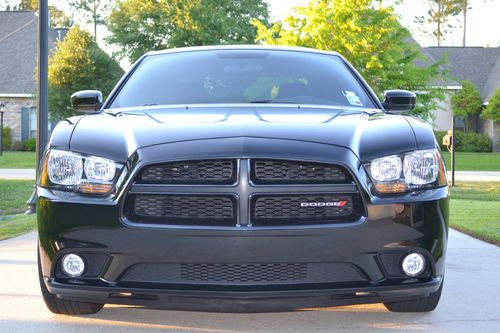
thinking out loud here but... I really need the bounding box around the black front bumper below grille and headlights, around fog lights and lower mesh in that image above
[38,193,448,311]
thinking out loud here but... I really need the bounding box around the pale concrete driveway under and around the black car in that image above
[0,231,500,333]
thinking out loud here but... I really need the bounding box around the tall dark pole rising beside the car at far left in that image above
[27,0,49,213]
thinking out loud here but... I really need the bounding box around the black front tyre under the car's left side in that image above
[38,248,104,316]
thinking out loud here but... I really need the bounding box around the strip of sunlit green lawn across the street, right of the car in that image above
[443,151,500,172]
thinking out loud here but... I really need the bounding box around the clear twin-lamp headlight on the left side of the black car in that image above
[42,150,120,194]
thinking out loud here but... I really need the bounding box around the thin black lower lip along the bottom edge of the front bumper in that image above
[46,277,443,312]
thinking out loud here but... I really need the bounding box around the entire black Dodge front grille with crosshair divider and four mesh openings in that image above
[123,159,366,227]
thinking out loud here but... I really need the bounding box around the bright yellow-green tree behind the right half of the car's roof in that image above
[254,0,442,119]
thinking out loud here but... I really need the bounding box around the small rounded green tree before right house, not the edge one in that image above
[451,80,483,129]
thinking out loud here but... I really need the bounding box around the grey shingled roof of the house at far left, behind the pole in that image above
[0,11,62,95]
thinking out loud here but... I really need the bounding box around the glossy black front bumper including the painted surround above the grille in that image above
[37,141,448,311]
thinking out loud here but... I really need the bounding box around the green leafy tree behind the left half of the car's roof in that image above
[107,0,269,61]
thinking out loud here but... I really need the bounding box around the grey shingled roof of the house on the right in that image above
[424,46,500,102]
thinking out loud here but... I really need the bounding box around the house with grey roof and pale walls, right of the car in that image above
[423,46,500,151]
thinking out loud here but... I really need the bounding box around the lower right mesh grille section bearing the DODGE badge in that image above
[252,195,353,225]
